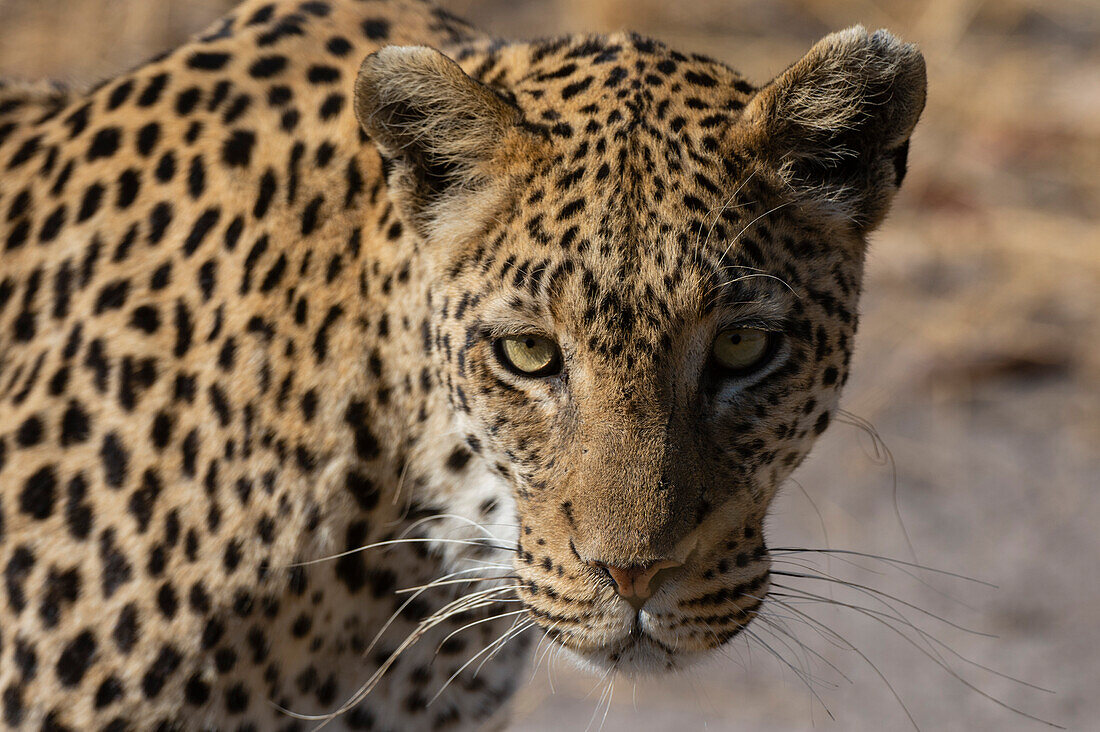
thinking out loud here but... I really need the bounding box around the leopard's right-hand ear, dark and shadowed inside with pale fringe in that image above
[741,26,926,232]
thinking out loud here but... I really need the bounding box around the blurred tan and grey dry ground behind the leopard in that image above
[0,0,1100,731]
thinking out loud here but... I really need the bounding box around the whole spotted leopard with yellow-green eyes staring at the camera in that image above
[0,0,926,732]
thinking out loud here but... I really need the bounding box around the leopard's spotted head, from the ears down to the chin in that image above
[360,27,923,674]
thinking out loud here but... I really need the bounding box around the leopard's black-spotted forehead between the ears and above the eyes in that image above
[442,34,813,363]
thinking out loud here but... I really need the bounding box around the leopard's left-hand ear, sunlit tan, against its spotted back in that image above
[355,46,530,231]
